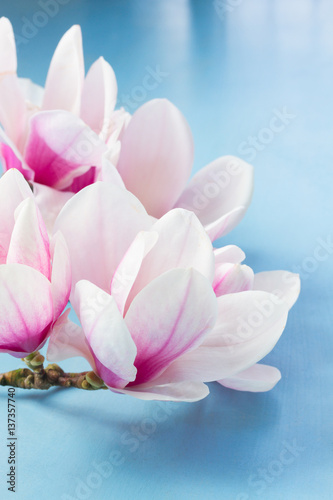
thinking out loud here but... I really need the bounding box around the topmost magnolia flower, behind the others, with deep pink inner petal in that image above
[0,18,253,240]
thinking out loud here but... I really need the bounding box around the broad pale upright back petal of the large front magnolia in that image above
[54,182,151,292]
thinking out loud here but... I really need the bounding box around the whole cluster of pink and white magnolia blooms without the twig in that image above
[0,18,299,401]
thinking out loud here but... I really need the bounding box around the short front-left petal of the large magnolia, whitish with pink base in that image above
[74,280,136,388]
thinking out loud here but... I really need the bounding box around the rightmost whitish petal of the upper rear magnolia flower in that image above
[175,156,253,240]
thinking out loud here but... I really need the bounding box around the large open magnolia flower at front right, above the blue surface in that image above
[48,182,299,401]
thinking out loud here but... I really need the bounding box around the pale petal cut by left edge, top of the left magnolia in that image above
[0,169,33,264]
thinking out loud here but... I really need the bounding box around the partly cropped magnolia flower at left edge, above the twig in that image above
[0,169,71,358]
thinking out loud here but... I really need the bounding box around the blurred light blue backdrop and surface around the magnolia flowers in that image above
[0,0,333,500]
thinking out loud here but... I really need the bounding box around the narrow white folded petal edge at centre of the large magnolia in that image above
[111,231,158,314]
